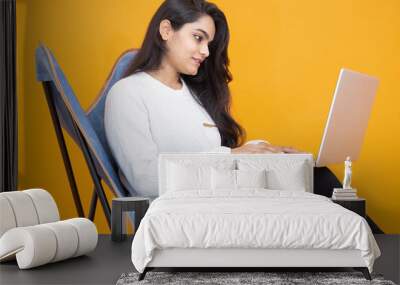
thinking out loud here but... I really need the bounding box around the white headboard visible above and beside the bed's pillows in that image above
[158,152,314,195]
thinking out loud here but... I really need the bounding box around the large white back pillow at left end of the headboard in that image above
[167,162,211,191]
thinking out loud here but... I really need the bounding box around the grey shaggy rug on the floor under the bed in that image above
[117,271,395,285]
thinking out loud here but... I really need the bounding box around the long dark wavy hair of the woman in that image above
[125,0,245,147]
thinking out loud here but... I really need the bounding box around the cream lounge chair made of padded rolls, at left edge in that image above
[0,189,98,269]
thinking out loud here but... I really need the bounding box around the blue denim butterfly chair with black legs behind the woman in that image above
[36,44,141,228]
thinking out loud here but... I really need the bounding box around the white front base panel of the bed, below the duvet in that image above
[147,248,367,267]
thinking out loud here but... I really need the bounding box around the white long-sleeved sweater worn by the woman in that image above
[104,72,230,197]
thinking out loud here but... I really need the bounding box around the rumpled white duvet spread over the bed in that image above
[132,189,380,272]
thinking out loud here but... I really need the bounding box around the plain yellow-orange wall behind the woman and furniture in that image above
[17,0,400,233]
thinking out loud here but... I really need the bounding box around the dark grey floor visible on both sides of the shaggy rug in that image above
[0,235,400,285]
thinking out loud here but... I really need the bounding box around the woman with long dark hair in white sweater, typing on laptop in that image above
[105,0,297,196]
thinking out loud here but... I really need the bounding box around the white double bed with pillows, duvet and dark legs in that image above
[132,153,380,280]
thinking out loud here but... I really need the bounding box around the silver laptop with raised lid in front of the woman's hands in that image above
[315,68,379,167]
